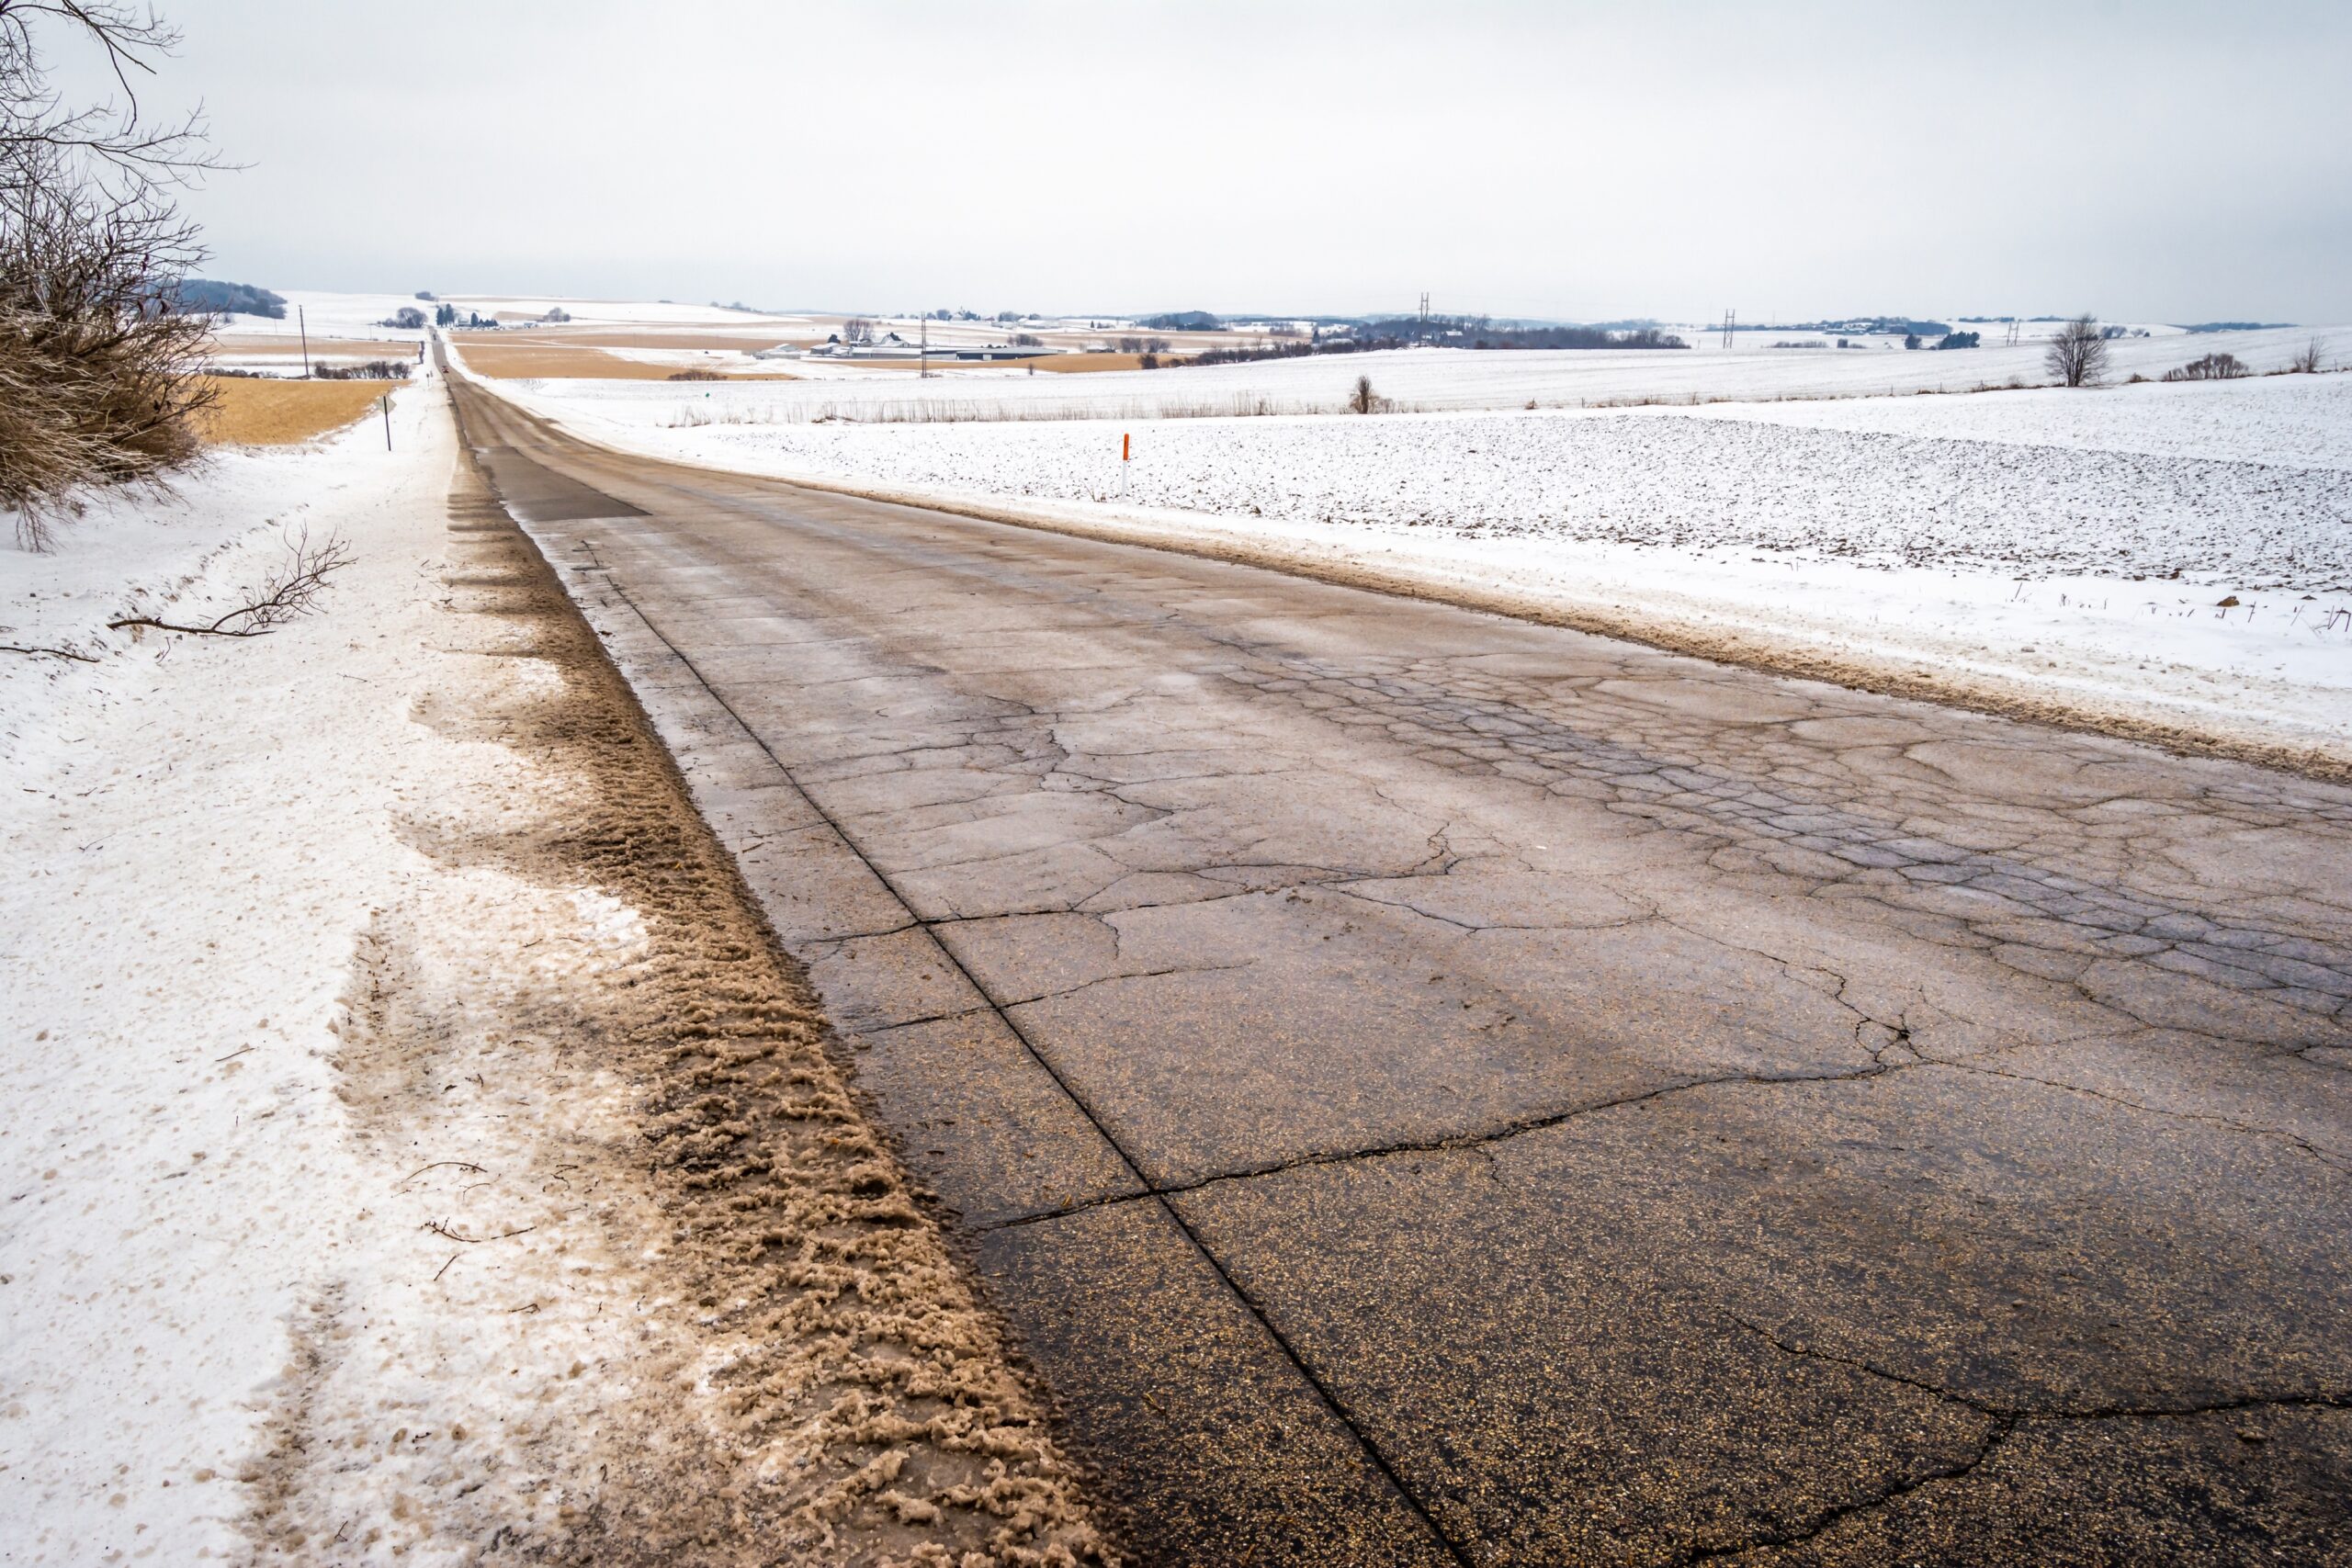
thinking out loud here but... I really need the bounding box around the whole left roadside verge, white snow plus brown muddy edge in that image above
[0,371,1101,1565]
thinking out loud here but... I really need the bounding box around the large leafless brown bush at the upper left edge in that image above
[0,0,211,547]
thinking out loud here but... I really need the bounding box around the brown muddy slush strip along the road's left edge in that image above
[247,466,1114,1568]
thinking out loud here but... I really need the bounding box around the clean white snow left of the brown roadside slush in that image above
[0,390,517,1563]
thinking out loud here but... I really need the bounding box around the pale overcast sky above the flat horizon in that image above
[83,0,2352,322]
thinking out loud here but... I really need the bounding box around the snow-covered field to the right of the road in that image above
[477,357,2352,766]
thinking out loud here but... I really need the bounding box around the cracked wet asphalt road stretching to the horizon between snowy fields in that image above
[454,381,2352,1568]
